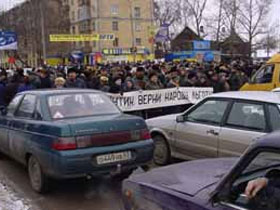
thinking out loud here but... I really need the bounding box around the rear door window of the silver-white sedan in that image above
[226,102,266,131]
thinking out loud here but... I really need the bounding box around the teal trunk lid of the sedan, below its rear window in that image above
[56,114,146,136]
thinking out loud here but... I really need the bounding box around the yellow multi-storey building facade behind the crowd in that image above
[65,0,154,61]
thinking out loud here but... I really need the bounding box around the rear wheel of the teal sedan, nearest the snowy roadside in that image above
[28,156,48,193]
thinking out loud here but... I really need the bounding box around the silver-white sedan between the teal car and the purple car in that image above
[146,91,280,165]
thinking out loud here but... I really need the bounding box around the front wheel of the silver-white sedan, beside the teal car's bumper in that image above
[153,135,171,166]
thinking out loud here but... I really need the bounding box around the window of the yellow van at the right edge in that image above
[252,65,274,84]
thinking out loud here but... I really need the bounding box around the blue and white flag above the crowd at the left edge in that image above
[0,31,18,50]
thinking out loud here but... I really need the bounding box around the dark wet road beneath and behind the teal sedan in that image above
[0,154,139,210]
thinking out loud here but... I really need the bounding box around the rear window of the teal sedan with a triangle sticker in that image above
[48,93,120,120]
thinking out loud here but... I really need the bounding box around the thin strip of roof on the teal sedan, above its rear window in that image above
[18,88,102,95]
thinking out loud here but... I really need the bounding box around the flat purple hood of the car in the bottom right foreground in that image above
[129,158,238,196]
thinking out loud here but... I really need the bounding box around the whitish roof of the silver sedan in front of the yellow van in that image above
[209,91,280,104]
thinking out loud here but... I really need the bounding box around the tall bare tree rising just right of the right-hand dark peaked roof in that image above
[238,0,272,57]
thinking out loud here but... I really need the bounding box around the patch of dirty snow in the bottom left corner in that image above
[0,182,31,210]
